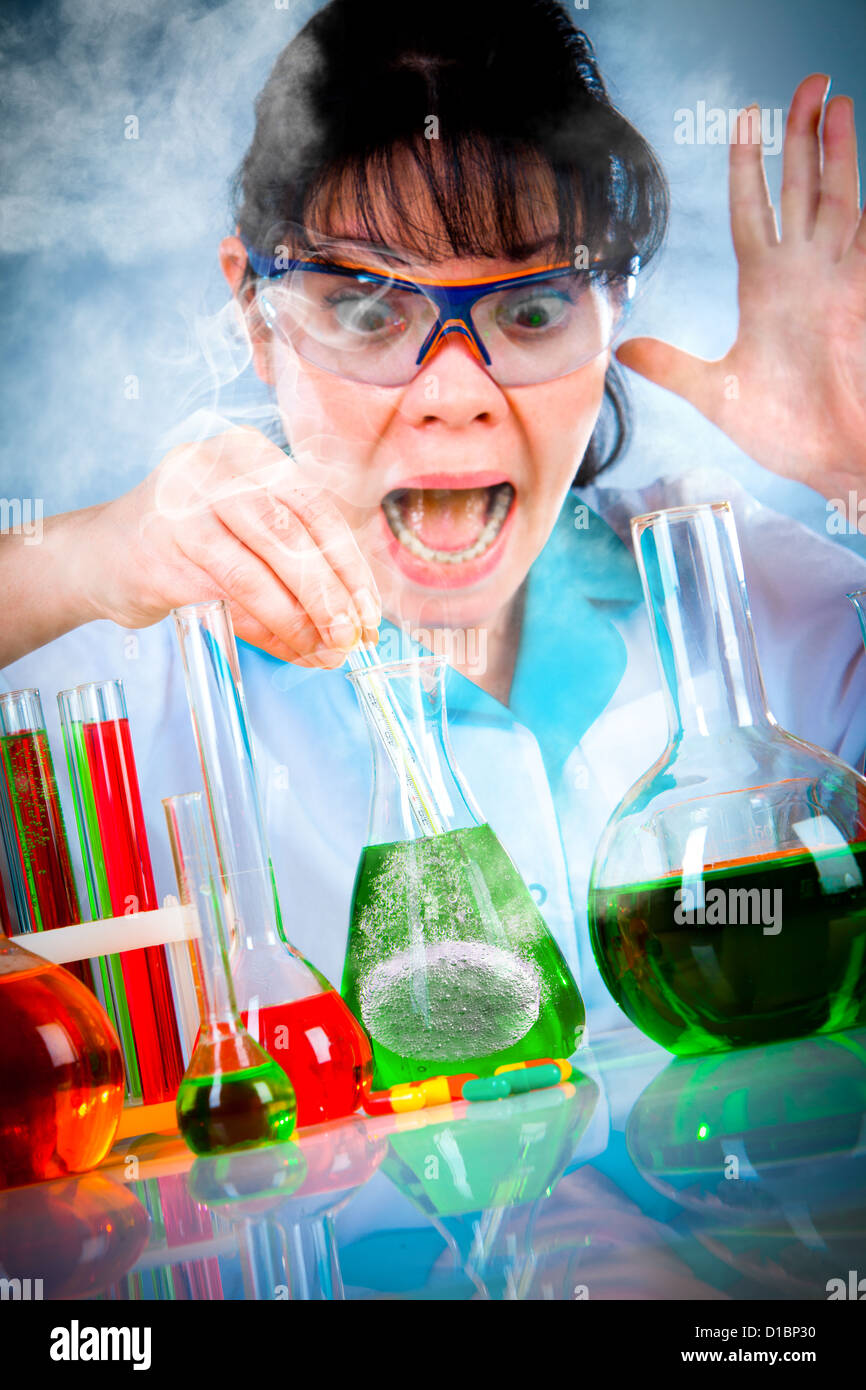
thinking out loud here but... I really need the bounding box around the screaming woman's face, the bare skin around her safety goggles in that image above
[222,187,609,628]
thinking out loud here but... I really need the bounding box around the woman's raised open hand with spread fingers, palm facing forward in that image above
[617,74,866,498]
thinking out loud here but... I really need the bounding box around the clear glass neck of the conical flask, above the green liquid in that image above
[349,657,482,845]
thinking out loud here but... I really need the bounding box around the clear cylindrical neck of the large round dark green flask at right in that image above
[631,502,776,739]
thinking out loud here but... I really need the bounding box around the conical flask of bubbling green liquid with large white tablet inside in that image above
[342,657,584,1088]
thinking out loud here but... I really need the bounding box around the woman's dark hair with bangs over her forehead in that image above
[235,0,667,484]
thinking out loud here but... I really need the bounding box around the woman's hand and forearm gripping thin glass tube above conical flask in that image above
[0,427,381,669]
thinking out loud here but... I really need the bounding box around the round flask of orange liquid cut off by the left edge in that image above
[0,937,124,1187]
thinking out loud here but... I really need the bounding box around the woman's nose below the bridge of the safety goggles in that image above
[400,331,509,430]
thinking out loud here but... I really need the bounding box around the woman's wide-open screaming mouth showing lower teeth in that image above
[382,482,516,564]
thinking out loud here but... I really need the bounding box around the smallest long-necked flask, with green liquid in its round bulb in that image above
[163,792,296,1154]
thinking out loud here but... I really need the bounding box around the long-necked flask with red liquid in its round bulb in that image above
[174,599,371,1127]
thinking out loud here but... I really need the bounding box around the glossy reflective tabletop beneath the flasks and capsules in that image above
[0,1029,866,1301]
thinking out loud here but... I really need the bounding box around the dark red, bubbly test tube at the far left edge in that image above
[0,689,93,988]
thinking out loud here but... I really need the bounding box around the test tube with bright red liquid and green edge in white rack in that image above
[57,680,183,1104]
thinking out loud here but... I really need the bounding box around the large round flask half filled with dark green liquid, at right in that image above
[589,502,866,1055]
